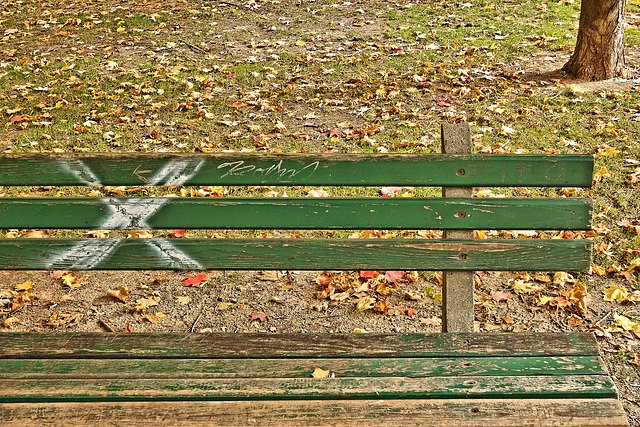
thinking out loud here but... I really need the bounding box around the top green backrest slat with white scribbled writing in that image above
[0,153,593,187]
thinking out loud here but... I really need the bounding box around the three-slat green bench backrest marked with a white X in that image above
[0,142,593,271]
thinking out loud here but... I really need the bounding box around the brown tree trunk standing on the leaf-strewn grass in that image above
[562,0,626,80]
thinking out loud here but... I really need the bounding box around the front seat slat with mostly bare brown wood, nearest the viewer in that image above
[1,399,628,427]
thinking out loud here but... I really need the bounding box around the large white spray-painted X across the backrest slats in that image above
[46,158,205,270]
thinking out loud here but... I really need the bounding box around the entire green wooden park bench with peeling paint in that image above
[0,125,627,427]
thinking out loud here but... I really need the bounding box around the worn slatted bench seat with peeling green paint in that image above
[0,333,627,426]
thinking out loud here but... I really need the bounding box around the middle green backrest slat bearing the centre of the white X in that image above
[0,198,592,230]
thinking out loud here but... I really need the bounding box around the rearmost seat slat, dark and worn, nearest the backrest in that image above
[0,332,599,360]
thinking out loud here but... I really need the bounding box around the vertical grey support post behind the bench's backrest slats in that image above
[441,123,474,332]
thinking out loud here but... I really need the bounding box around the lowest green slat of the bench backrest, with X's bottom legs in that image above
[0,239,591,271]
